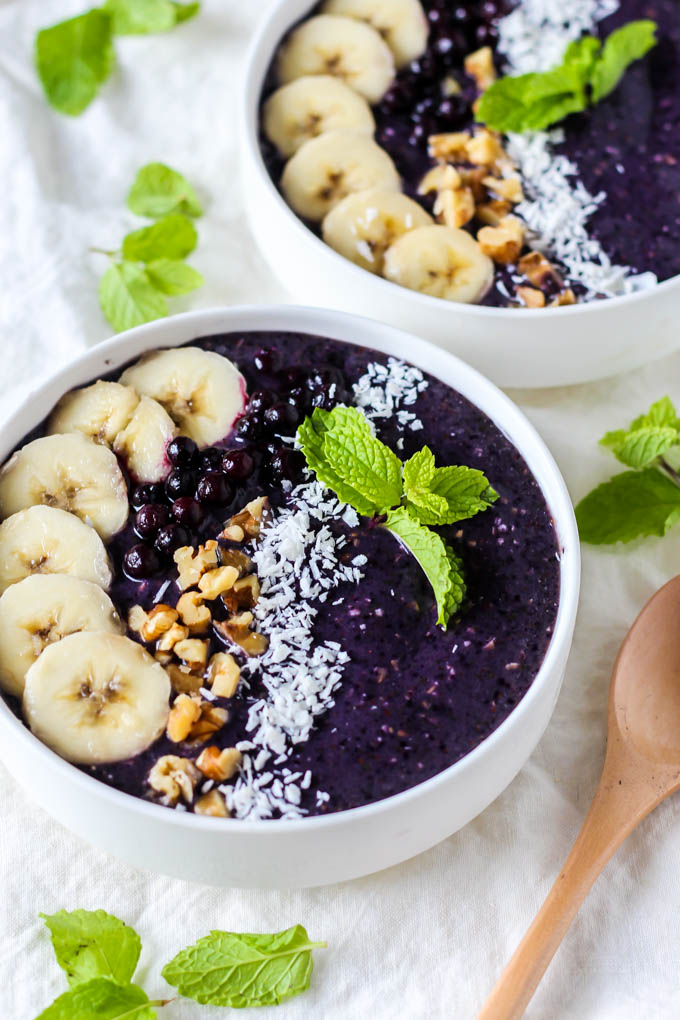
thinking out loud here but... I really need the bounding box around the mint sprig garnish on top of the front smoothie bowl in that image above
[297,406,499,629]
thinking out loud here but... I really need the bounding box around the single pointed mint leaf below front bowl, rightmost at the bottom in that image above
[162,924,325,1009]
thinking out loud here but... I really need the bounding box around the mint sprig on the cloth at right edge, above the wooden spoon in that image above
[576,397,680,545]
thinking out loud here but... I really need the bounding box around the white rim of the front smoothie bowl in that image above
[0,305,580,838]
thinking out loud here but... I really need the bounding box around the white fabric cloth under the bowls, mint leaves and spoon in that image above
[0,0,680,1020]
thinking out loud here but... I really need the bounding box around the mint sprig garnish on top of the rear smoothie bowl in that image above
[475,20,657,133]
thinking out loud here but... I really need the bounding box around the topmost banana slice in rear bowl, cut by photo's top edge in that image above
[321,0,428,67]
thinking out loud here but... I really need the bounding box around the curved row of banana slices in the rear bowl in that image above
[262,0,493,303]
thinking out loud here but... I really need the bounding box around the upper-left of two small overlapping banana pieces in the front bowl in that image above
[47,379,140,446]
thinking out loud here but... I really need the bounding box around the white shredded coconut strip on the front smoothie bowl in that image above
[219,358,428,819]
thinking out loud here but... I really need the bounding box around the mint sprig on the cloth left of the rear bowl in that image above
[95,163,204,333]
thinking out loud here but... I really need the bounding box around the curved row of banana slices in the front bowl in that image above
[0,347,246,765]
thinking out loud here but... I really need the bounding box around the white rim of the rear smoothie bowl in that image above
[239,0,680,318]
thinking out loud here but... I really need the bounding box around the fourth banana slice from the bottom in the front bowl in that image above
[0,432,127,542]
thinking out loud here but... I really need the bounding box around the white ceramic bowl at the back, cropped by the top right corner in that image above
[240,0,680,387]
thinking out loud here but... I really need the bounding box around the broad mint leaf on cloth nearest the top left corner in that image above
[36,9,115,116]
